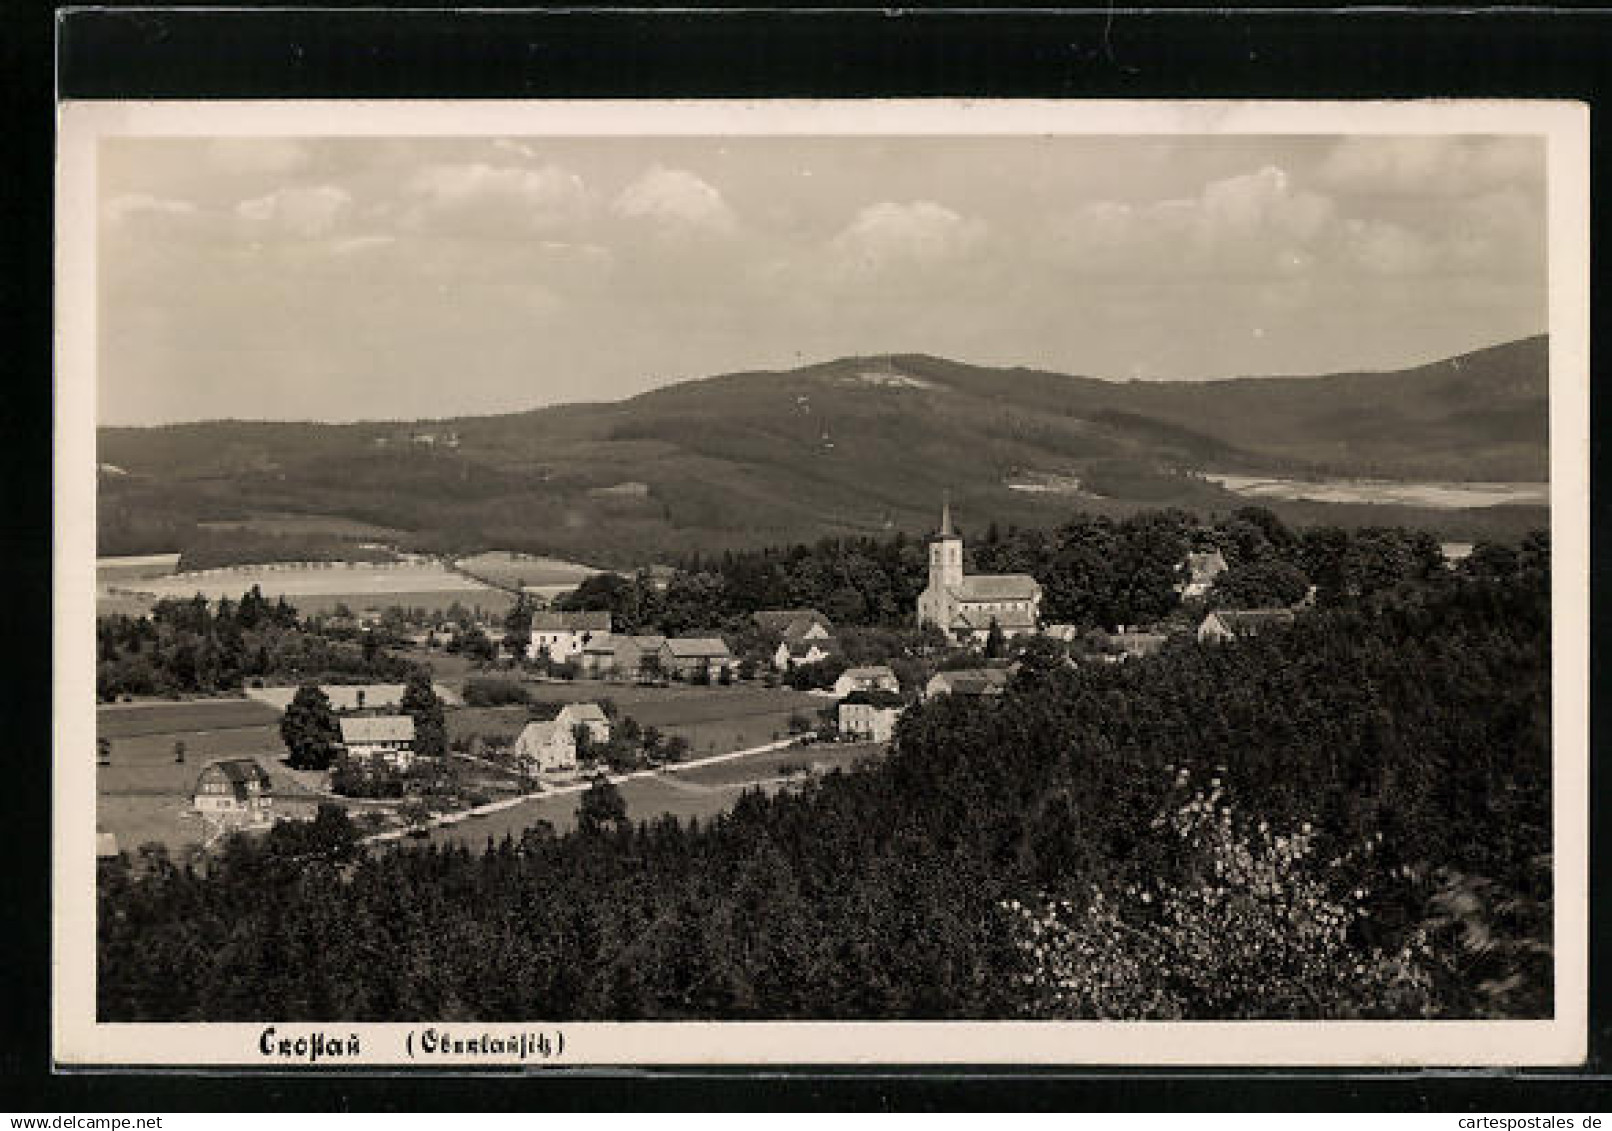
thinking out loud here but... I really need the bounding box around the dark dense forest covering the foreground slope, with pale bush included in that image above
[97,533,1552,1021]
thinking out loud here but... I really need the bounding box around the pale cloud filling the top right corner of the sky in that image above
[1317,137,1544,197]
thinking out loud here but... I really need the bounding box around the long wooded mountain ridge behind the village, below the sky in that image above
[98,337,1549,561]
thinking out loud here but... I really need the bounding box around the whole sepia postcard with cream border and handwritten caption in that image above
[55,102,1589,1067]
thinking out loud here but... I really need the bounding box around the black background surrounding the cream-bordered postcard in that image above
[0,6,1612,1115]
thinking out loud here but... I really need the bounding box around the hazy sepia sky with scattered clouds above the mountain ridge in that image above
[97,135,1548,425]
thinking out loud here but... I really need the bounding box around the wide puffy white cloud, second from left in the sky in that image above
[403,161,588,238]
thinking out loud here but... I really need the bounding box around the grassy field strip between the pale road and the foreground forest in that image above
[419,743,880,847]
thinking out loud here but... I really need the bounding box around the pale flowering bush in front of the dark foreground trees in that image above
[1004,769,1431,1020]
